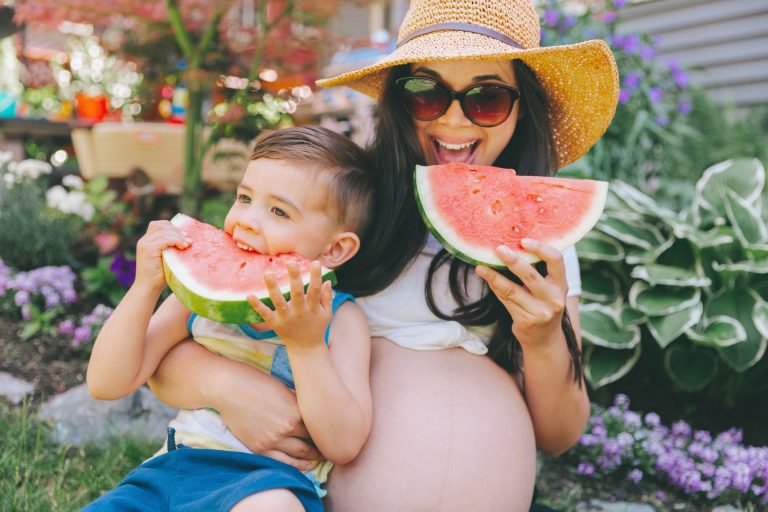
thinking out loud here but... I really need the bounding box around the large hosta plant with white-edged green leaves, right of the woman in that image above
[577,159,768,400]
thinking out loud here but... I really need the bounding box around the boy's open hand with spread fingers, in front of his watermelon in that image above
[248,261,333,349]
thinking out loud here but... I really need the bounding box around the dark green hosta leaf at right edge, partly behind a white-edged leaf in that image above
[705,287,768,373]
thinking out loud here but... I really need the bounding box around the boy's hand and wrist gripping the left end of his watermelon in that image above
[134,220,192,290]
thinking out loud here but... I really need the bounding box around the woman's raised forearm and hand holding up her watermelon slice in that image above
[477,241,589,455]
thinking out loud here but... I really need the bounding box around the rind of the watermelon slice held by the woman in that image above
[413,165,608,269]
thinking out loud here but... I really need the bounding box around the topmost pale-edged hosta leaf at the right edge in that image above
[695,158,765,213]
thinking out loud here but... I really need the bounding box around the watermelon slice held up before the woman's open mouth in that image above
[413,163,608,268]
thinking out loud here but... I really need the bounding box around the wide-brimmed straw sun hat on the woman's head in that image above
[317,0,619,167]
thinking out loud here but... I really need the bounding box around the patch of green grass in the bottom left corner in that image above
[0,403,157,512]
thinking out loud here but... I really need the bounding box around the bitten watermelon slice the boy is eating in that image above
[163,213,336,324]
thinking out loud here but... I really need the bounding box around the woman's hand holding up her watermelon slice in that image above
[476,238,568,348]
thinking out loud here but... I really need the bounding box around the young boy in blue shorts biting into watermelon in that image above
[85,127,373,512]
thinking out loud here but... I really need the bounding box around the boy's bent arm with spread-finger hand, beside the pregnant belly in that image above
[248,261,371,464]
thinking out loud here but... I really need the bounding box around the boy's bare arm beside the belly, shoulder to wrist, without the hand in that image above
[288,302,372,464]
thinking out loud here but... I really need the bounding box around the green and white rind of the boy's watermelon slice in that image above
[163,214,337,324]
